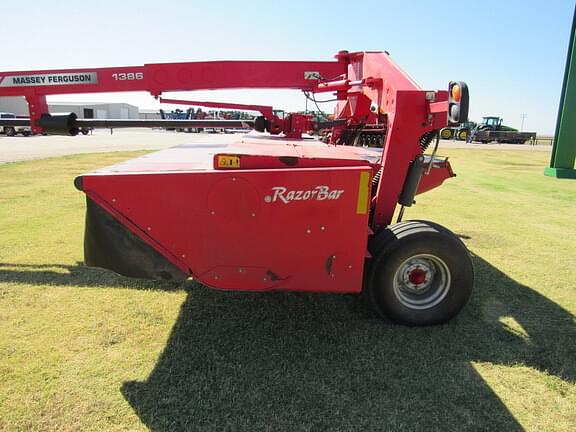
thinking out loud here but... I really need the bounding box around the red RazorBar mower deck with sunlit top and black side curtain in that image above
[76,136,381,292]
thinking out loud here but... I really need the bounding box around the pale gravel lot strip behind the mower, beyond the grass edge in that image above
[0,129,552,163]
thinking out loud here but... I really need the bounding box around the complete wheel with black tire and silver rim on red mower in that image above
[364,221,474,325]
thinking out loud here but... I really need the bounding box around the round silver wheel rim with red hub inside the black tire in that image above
[393,254,451,310]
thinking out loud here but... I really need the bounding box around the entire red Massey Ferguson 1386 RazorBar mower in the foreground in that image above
[0,51,474,325]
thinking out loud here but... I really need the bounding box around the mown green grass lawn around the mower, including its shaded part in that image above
[0,150,576,431]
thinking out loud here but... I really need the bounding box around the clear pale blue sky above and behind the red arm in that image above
[0,0,574,133]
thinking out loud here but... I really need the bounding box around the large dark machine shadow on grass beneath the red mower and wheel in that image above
[122,257,576,431]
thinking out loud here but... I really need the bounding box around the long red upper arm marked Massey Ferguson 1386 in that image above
[0,61,346,96]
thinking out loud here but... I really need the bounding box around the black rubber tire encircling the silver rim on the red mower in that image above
[364,221,474,326]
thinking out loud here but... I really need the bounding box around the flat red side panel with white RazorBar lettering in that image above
[83,166,372,292]
